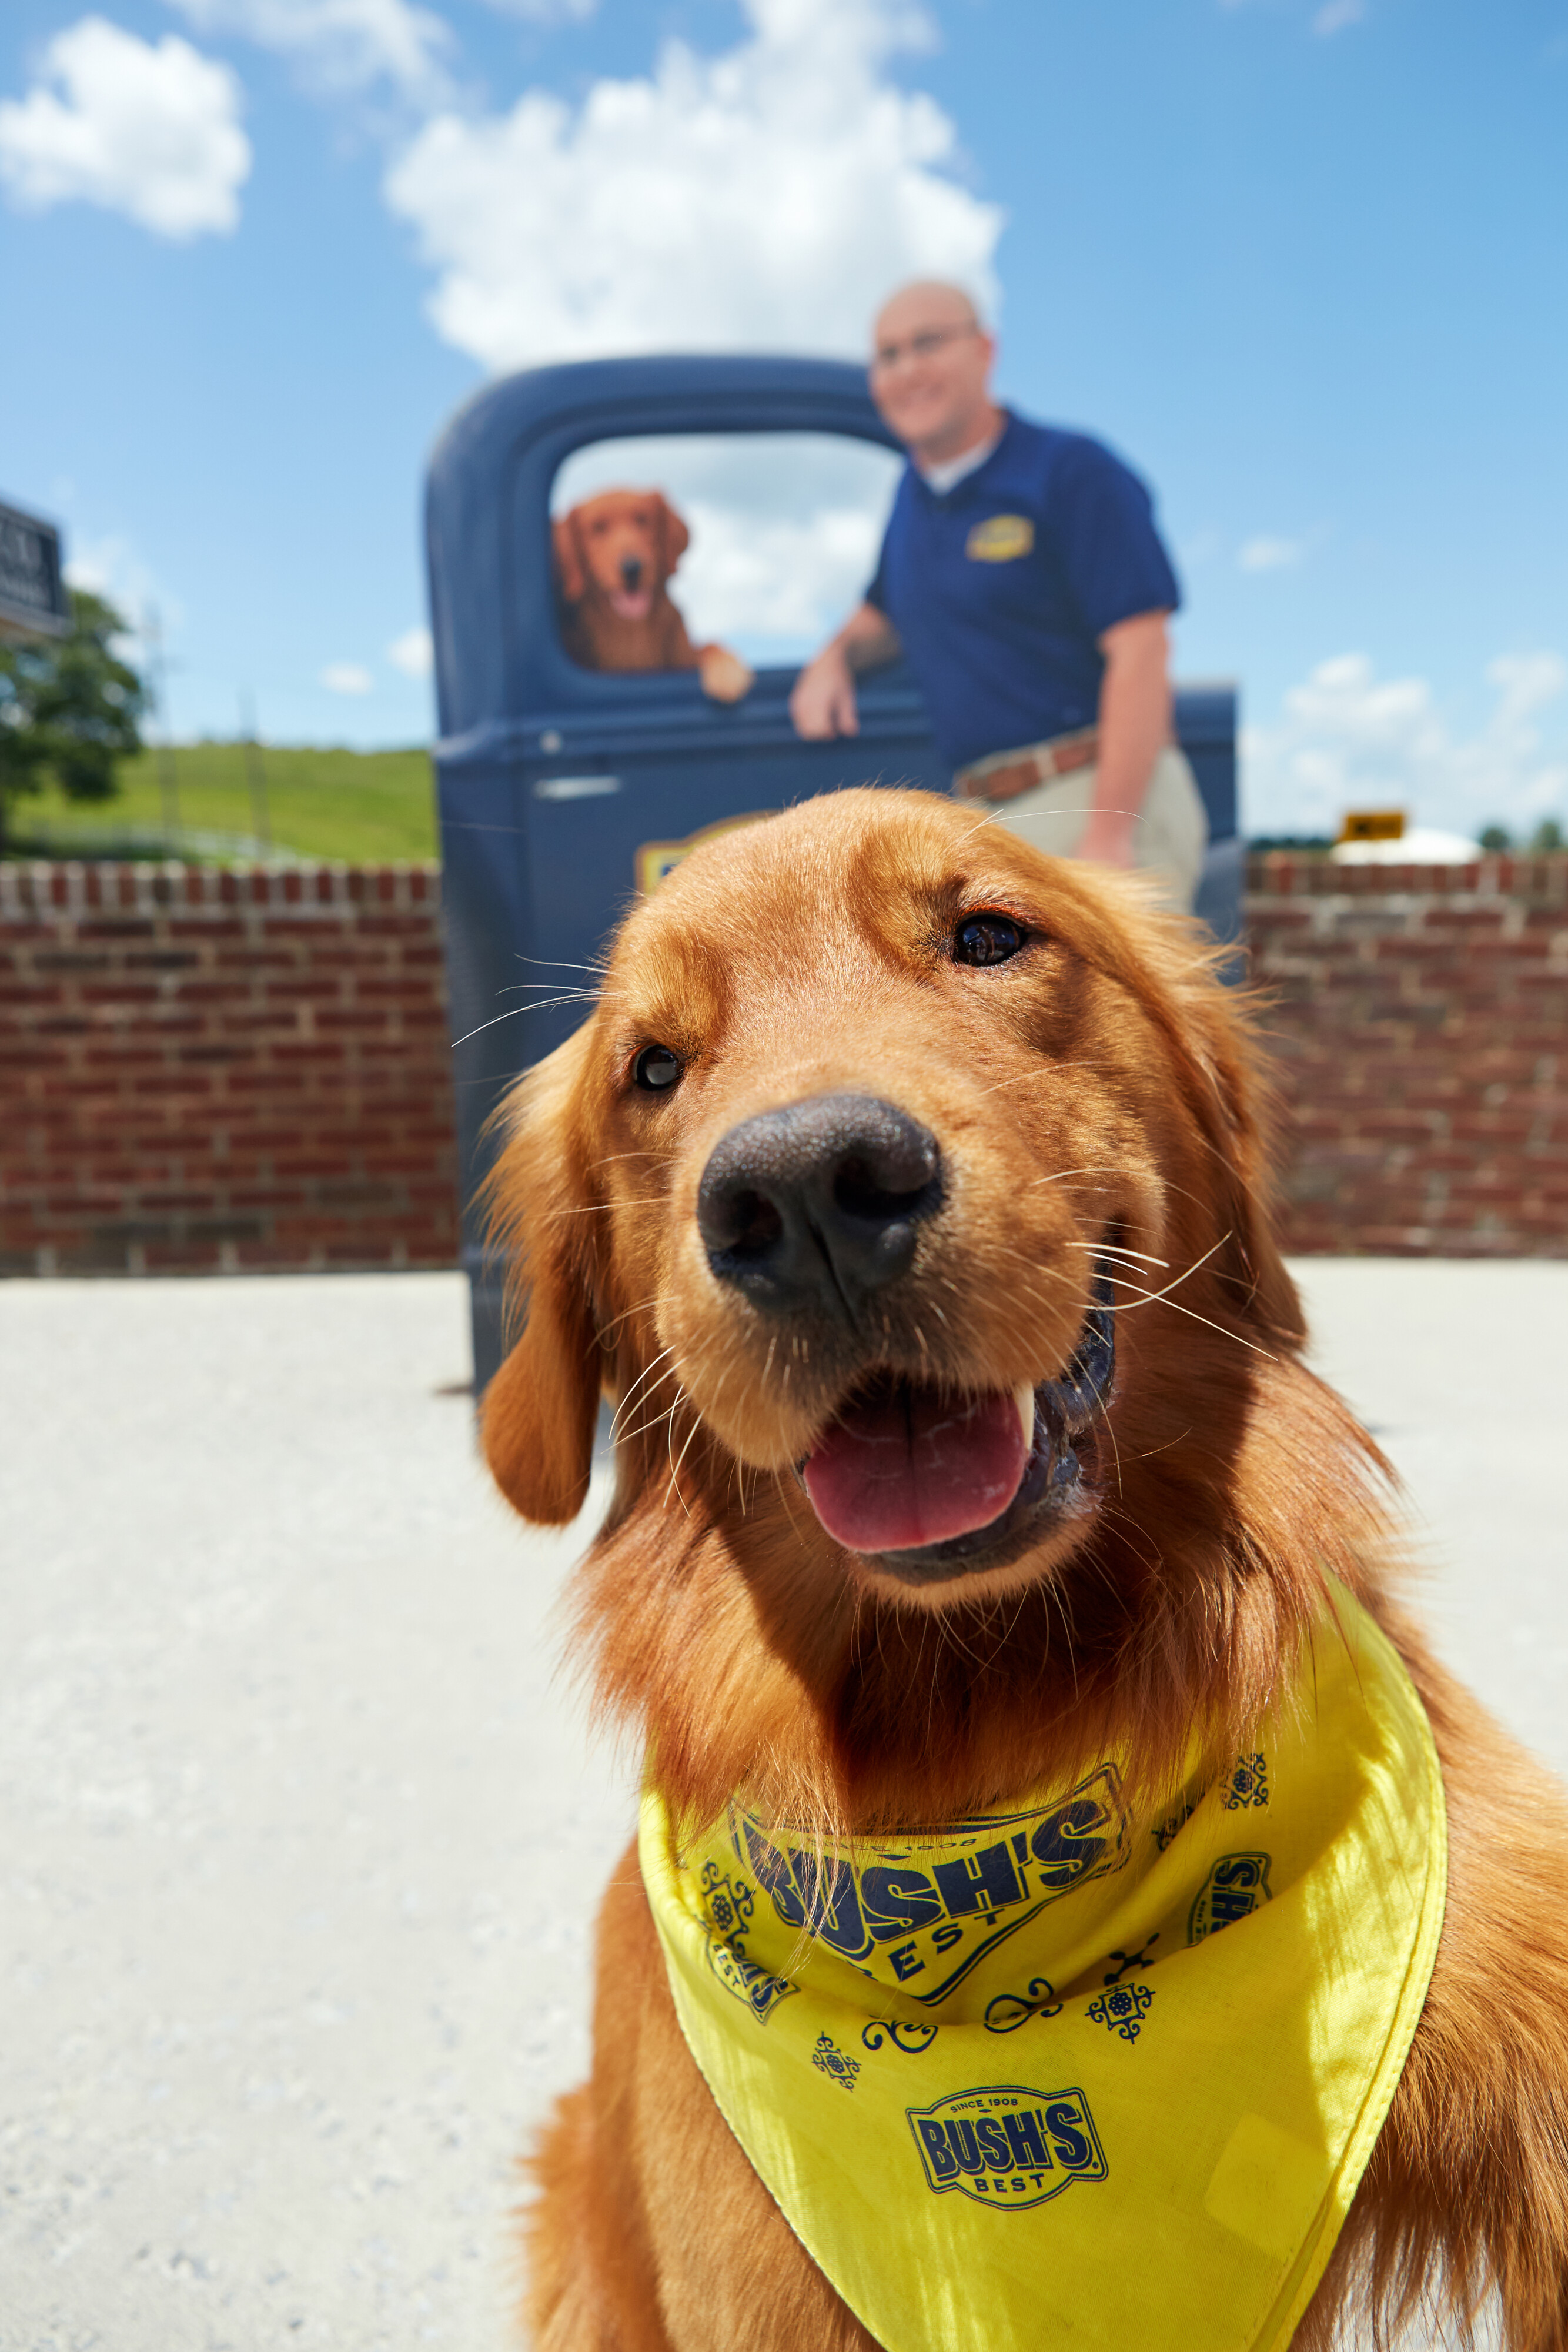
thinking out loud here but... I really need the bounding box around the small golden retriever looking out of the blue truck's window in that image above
[553,489,753,703]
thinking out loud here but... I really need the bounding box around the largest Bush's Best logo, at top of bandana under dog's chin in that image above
[720,1764,1128,2006]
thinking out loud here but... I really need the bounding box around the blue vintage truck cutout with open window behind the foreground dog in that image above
[426,358,1241,1390]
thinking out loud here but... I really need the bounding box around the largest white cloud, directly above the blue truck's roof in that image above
[386,0,1001,369]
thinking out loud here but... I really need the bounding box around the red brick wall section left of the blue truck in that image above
[0,866,456,1272]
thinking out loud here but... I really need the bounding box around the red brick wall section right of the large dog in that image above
[1246,856,1568,1258]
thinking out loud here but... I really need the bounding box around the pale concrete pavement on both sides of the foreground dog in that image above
[0,1261,1568,2352]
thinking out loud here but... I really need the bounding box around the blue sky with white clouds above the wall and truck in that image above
[0,0,1568,830]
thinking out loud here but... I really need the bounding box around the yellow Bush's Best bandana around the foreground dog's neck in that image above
[642,1595,1448,2352]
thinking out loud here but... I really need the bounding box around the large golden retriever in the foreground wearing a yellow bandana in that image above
[482,790,1568,2352]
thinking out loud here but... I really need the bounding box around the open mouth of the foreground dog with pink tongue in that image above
[801,1265,1116,1583]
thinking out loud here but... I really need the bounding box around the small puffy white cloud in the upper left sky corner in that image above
[0,16,252,238]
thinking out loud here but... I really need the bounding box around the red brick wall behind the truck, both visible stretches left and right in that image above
[0,856,1568,1272]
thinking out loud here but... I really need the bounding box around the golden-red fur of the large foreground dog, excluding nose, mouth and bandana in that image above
[484,793,1568,2352]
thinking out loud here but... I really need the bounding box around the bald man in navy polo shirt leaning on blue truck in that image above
[790,282,1208,906]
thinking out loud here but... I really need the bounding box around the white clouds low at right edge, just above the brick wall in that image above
[1241,652,1568,833]
